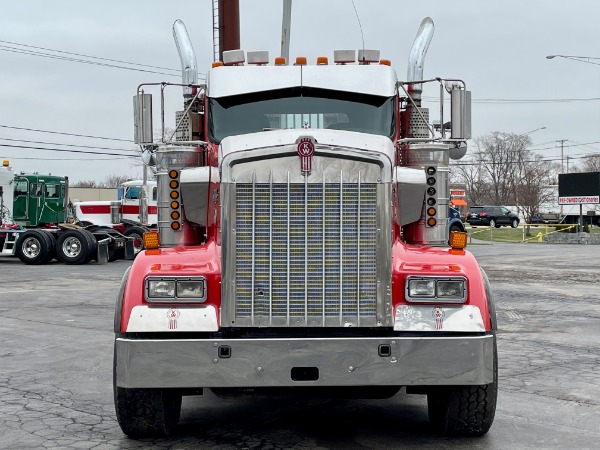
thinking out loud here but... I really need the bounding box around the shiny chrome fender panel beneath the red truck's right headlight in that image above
[394,305,486,333]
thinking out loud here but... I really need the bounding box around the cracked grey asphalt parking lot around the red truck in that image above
[0,244,600,449]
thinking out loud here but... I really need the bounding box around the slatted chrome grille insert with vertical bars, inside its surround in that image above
[233,176,378,326]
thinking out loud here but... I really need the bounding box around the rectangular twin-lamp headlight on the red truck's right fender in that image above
[406,277,467,303]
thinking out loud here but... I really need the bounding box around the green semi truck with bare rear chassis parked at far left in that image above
[0,160,134,264]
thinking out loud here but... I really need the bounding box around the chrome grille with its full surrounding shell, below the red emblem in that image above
[221,145,393,327]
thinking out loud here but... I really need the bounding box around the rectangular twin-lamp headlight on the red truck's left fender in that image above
[145,277,206,303]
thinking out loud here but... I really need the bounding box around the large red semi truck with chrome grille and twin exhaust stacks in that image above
[114,18,498,437]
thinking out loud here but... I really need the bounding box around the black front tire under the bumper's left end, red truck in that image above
[113,349,181,439]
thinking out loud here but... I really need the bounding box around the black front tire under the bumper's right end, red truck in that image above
[427,336,498,436]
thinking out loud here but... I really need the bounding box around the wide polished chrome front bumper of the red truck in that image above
[115,335,494,388]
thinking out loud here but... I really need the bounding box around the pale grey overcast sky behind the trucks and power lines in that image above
[0,0,600,181]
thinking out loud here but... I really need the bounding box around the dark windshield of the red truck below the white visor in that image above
[209,87,395,142]
